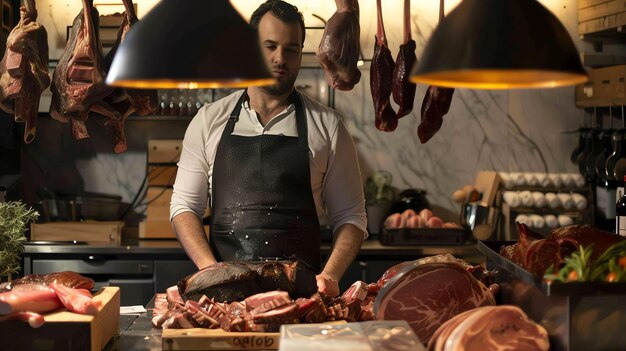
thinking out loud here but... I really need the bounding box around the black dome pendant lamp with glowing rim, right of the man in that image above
[410,0,588,89]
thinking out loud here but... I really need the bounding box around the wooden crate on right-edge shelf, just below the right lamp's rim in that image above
[576,65,626,107]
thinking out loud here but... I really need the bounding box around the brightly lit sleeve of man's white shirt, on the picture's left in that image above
[170,114,209,221]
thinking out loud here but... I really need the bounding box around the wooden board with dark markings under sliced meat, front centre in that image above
[162,321,346,350]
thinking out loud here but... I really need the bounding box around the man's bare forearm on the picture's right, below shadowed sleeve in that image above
[322,224,365,281]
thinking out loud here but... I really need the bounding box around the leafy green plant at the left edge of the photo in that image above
[0,201,39,276]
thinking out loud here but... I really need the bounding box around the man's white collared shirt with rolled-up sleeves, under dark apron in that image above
[170,90,367,238]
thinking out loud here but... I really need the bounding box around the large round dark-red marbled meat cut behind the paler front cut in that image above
[374,262,495,343]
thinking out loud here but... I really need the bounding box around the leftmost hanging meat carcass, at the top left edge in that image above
[0,0,50,144]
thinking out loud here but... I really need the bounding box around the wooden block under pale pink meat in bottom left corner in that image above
[0,287,120,351]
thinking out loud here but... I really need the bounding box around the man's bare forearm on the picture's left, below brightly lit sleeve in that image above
[172,212,217,269]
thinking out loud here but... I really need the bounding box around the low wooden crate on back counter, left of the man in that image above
[30,221,124,245]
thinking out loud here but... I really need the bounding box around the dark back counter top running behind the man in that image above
[24,239,481,257]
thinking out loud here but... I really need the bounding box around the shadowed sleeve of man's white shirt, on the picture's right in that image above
[323,120,368,238]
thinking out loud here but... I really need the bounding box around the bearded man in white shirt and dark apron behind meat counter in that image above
[170,0,367,296]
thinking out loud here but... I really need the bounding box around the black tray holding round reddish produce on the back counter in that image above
[379,228,470,246]
